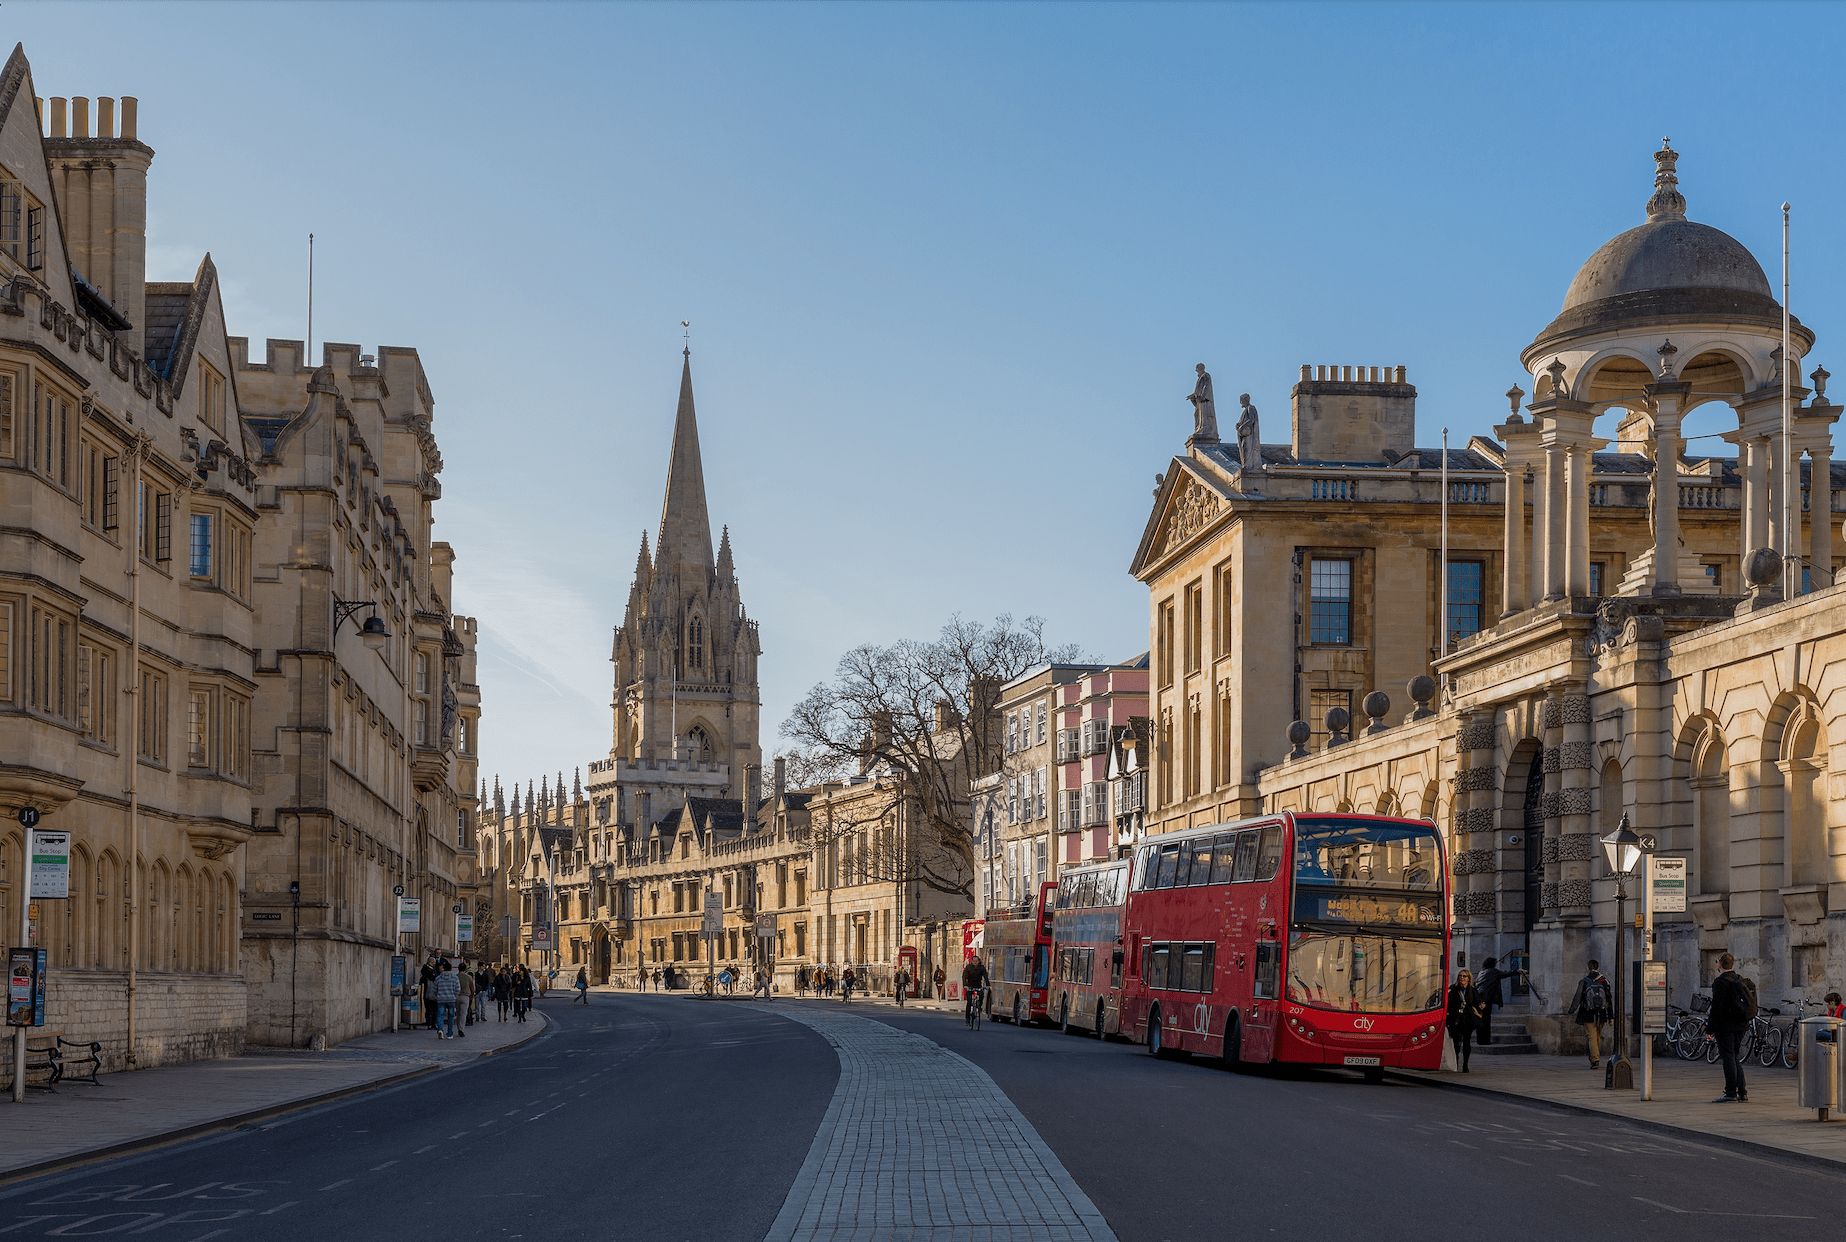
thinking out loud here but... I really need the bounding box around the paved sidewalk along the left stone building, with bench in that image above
[0,1011,545,1181]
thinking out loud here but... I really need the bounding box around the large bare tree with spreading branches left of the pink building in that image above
[781,615,1084,897]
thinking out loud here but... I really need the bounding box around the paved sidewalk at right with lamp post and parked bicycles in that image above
[1394,1052,1846,1168]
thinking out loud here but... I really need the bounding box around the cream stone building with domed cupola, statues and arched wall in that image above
[1137,140,1846,1050]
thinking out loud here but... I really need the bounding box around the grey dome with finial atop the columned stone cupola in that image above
[1527,140,1811,354]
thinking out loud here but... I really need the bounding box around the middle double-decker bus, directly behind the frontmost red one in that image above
[1049,860,1128,1039]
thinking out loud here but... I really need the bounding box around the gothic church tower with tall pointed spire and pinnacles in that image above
[609,349,762,816]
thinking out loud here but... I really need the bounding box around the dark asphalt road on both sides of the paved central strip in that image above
[0,995,1846,1242]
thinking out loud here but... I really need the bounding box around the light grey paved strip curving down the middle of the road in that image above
[751,1000,1115,1242]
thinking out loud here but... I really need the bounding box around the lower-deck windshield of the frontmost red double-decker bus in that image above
[1289,928,1442,1013]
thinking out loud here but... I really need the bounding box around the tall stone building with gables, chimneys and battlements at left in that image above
[0,48,478,1070]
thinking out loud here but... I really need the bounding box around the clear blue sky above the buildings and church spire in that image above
[0,0,1846,781]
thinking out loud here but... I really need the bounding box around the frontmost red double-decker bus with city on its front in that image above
[1122,812,1449,1080]
